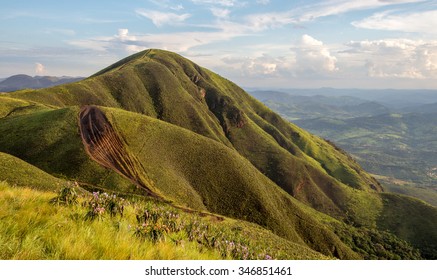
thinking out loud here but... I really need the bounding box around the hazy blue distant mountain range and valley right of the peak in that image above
[251,89,437,205]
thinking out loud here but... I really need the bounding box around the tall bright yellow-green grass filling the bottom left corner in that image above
[0,182,220,260]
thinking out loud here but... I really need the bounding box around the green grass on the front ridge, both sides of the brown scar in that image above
[0,103,358,258]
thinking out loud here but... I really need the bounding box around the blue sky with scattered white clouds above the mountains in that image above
[0,0,437,89]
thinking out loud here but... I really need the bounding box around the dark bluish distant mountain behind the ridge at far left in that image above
[0,74,83,92]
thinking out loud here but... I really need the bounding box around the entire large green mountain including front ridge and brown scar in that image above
[0,50,437,259]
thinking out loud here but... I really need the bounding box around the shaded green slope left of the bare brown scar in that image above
[0,107,135,195]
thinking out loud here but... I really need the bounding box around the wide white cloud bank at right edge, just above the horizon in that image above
[346,39,437,79]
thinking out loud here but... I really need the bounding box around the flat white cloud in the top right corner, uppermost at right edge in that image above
[352,10,437,34]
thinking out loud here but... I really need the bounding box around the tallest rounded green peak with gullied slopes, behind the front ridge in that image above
[5,50,381,217]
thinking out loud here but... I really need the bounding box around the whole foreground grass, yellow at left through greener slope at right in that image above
[0,182,324,260]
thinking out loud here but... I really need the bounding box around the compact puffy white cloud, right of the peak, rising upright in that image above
[293,34,338,75]
